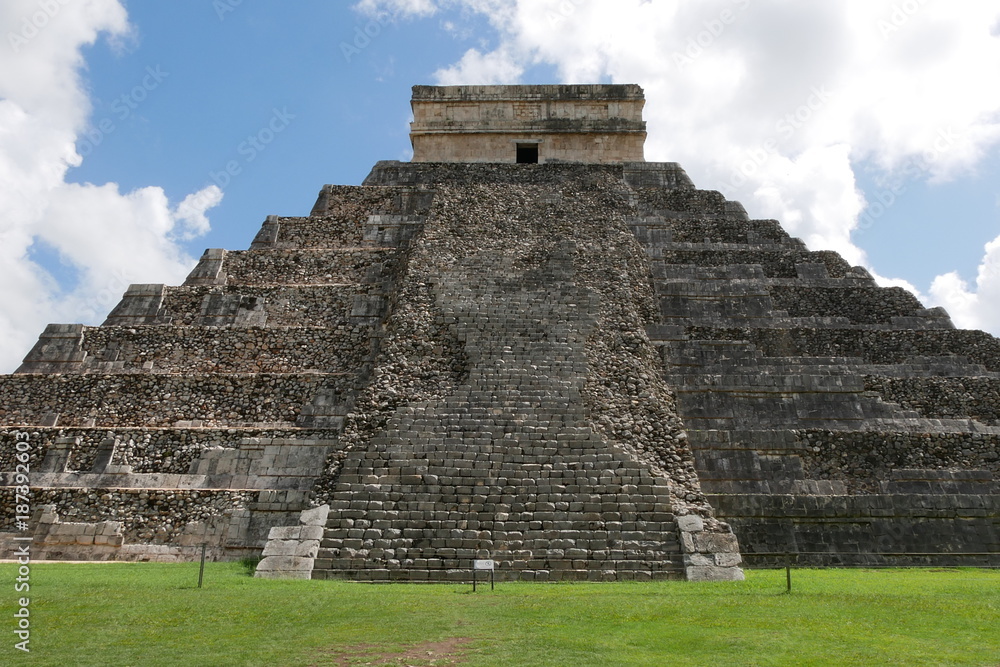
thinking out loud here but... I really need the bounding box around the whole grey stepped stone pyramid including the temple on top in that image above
[0,85,1000,581]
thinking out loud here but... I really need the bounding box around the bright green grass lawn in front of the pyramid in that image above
[0,563,1000,667]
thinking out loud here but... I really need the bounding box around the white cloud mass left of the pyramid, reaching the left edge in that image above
[0,0,222,371]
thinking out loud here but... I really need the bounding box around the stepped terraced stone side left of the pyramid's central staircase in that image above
[0,177,428,560]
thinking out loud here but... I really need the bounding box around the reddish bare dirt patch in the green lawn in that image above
[311,637,472,667]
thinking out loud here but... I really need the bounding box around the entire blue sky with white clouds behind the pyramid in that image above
[0,0,1000,371]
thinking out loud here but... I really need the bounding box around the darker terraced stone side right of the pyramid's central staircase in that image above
[629,179,1000,565]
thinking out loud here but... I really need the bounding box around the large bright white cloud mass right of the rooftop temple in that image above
[360,0,1000,333]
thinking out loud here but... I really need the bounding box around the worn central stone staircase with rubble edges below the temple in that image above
[313,165,742,580]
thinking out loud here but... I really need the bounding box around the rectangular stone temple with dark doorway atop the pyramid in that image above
[410,84,646,164]
